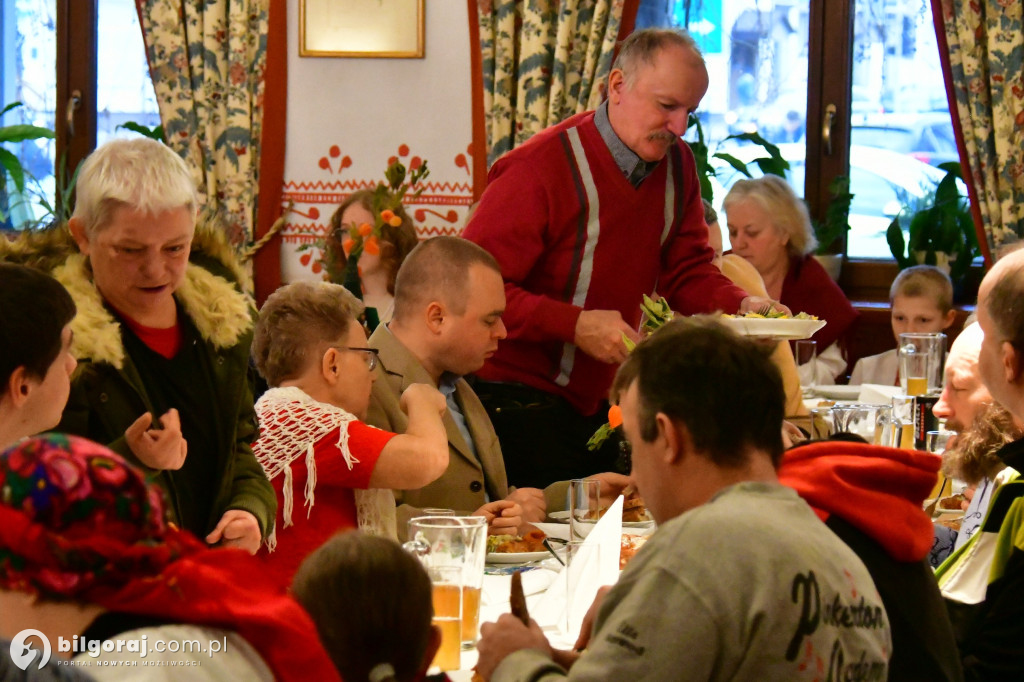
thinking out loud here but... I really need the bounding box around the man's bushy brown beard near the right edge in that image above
[942,402,1024,485]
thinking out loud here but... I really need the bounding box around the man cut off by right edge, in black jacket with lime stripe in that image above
[944,251,1024,680]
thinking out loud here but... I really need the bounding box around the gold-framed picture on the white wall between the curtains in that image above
[299,0,425,58]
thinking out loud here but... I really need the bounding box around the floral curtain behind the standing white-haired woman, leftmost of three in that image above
[135,0,269,246]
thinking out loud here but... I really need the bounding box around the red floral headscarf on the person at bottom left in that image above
[0,434,190,601]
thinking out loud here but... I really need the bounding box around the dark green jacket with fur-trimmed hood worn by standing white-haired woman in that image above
[0,227,278,536]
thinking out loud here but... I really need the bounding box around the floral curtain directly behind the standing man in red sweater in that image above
[477,0,625,167]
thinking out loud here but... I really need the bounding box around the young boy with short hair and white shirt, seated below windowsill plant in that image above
[850,265,956,386]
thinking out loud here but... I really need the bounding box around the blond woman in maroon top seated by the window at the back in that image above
[722,175,857,384]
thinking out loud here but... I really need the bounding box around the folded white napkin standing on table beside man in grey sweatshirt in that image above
[530,496,623,637]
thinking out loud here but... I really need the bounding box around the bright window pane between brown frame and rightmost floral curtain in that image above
[847,0,959,258]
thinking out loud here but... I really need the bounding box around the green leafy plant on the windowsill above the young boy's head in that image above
[886,162,981,285]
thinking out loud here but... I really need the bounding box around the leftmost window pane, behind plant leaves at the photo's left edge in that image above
[0,0,56,228]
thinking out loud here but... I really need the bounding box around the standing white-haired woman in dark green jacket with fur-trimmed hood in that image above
[0,139,276,553]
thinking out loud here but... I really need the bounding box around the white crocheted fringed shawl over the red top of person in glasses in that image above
[253,386,398,552]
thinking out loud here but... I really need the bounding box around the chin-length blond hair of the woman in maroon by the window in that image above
[722,175,818,258]
